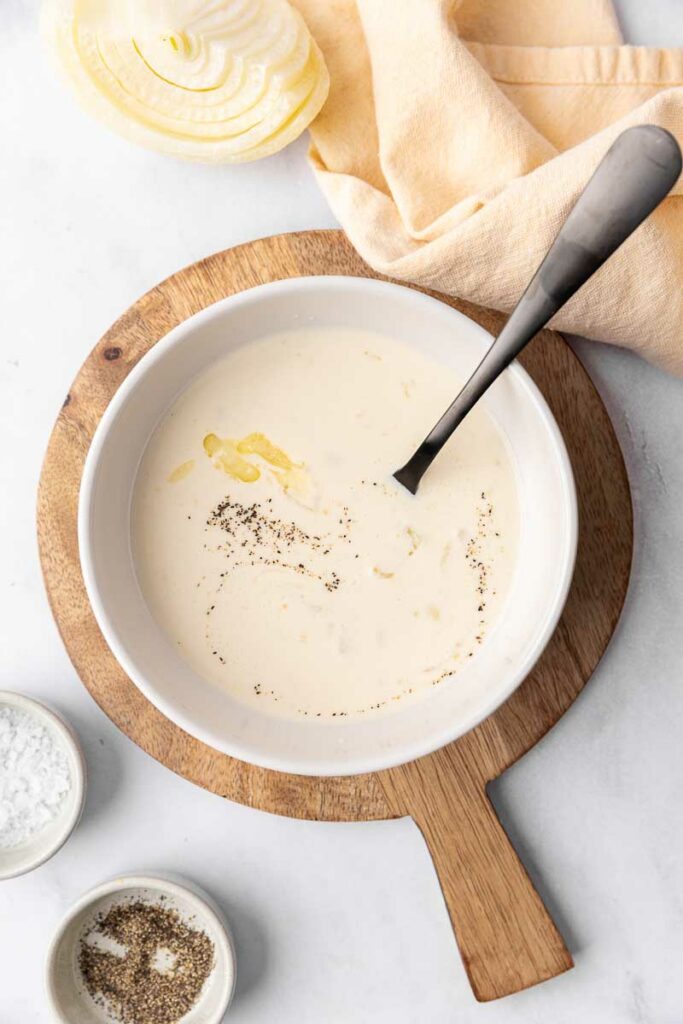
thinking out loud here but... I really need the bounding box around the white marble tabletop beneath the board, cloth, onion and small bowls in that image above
[0,0,683,1024]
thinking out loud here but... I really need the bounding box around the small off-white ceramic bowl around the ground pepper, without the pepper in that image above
[45,874,236,1024]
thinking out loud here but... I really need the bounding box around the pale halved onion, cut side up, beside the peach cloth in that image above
[43,0,330,163]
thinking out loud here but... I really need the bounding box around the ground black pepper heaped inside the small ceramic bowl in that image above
[79,899,214,1024]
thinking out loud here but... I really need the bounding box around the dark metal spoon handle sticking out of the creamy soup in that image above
[394,125,681,494]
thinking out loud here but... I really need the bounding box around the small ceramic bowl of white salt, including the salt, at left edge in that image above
[0,690,85,880]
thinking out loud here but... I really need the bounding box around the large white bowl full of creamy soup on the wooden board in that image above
[79,276,578,775]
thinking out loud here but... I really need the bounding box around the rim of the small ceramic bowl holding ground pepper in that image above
[44,872,237,1024]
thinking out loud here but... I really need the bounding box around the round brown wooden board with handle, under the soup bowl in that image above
[38,231,633,1000]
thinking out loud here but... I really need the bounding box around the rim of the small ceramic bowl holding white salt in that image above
[0,690,87,881]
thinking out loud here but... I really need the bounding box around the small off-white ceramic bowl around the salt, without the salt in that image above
[0,690,85,880]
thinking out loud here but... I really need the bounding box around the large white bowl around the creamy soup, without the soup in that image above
[79,278,578,775]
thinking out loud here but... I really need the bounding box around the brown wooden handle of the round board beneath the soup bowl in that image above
[380,744,573,1002]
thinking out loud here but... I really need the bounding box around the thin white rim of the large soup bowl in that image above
[78,274,579,777]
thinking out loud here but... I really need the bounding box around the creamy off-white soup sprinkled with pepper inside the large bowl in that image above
[132,329,518,718]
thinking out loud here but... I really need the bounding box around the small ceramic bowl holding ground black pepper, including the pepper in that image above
[46,874,236,1024]
